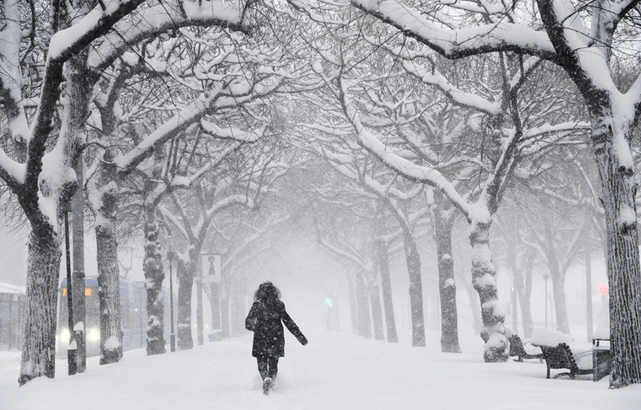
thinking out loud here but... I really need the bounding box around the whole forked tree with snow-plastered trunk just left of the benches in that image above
[318,32,576,361]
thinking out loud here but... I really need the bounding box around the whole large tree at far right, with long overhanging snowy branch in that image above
[352,0,641,388]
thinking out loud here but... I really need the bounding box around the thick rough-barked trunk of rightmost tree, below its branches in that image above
[592,115,641,388]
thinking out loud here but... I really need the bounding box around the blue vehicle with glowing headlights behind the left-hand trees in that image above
[56,278,170,356]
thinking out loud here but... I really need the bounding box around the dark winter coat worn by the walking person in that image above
[245,298,307,357]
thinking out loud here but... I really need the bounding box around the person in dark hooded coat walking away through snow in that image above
[245,282,307,394]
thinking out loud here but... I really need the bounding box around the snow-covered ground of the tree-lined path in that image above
[0,332,641,410]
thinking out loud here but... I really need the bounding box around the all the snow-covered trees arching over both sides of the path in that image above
[0,0,641,387]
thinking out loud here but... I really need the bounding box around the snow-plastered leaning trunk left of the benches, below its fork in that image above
[470,222,510,363]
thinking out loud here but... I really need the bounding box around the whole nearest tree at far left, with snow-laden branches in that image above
[0,0,255,385]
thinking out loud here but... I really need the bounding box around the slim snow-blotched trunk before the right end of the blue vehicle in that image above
[142,206,168,355]
